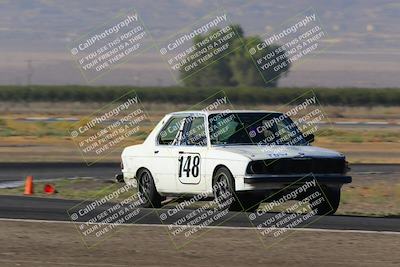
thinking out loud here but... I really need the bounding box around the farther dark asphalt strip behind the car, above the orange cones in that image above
[0,162,400,182]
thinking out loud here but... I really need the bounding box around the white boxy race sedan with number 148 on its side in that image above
[117,111,351,214]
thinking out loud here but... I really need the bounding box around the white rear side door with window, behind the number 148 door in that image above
[152,114,187,193]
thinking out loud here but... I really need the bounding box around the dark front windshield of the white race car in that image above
[208,112,307,145]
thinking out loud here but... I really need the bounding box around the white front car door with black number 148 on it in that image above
[175,114,208,193]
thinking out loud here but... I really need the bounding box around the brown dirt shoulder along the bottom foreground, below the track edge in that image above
[0,221,400,266]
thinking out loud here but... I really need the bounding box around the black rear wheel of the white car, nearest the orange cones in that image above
[137,169,161,208]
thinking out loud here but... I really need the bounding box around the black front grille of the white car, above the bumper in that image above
[247,158,346,174]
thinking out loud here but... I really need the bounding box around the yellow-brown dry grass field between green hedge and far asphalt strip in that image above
[0,102,400,163]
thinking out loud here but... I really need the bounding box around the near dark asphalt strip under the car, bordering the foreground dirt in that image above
[0,196,400,232]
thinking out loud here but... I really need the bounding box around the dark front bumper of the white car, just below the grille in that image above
[244,173,352,184]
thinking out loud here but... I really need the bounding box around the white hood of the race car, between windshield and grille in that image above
[215,145,343,160]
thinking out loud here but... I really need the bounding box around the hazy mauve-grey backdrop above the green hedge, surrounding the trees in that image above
[0,0,400,87]
